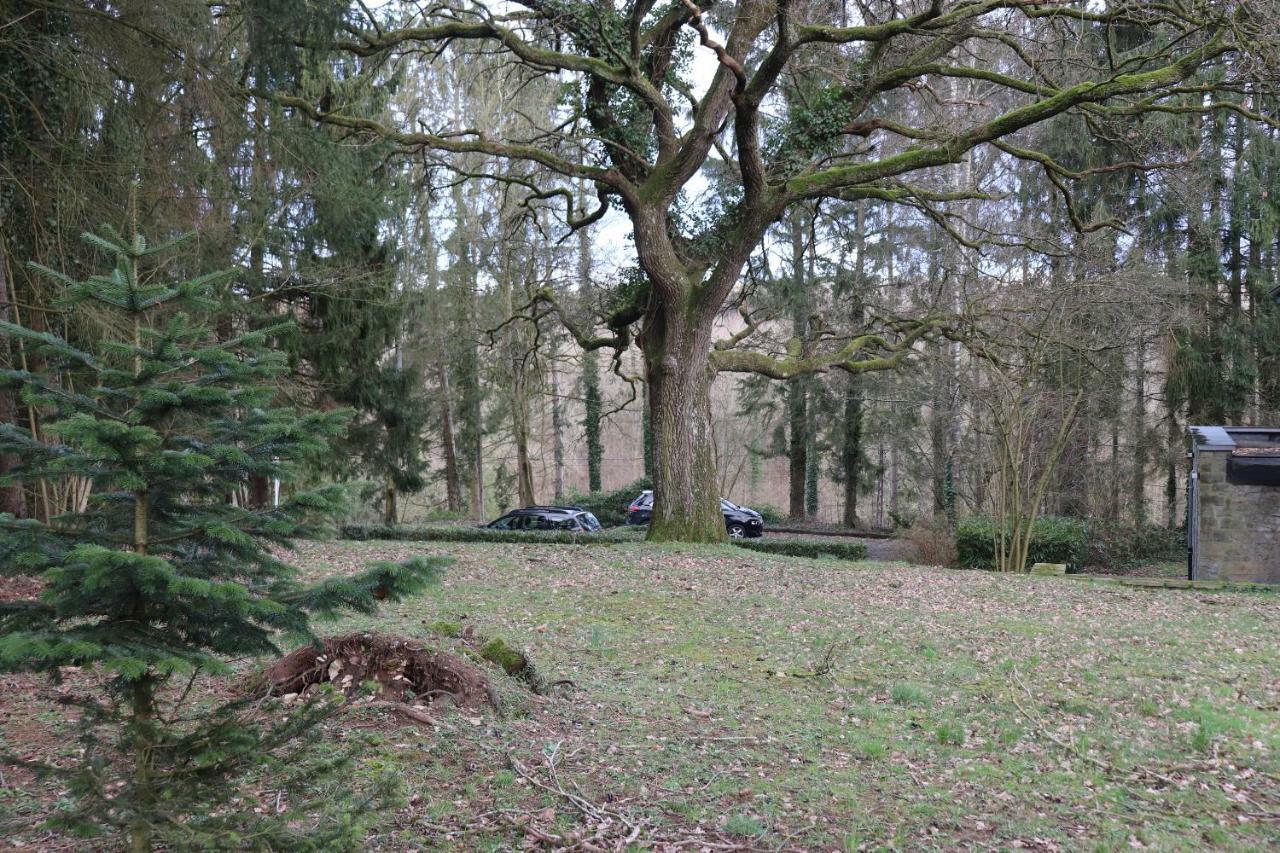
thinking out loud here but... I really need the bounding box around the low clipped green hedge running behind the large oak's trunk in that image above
[342,524,867,560]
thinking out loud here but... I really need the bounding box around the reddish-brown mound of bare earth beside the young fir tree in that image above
[262,633,498,708]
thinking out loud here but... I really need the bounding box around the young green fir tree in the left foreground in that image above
[0,231,440,850]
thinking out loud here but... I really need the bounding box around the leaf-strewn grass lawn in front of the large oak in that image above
[0,542,1280,850]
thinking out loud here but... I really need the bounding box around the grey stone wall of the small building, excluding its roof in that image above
[1196,451,1280,584]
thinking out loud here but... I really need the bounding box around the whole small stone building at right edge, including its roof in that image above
[1187,427,1280,584]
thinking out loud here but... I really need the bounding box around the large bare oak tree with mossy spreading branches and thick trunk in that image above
[273,0,1275,540]
